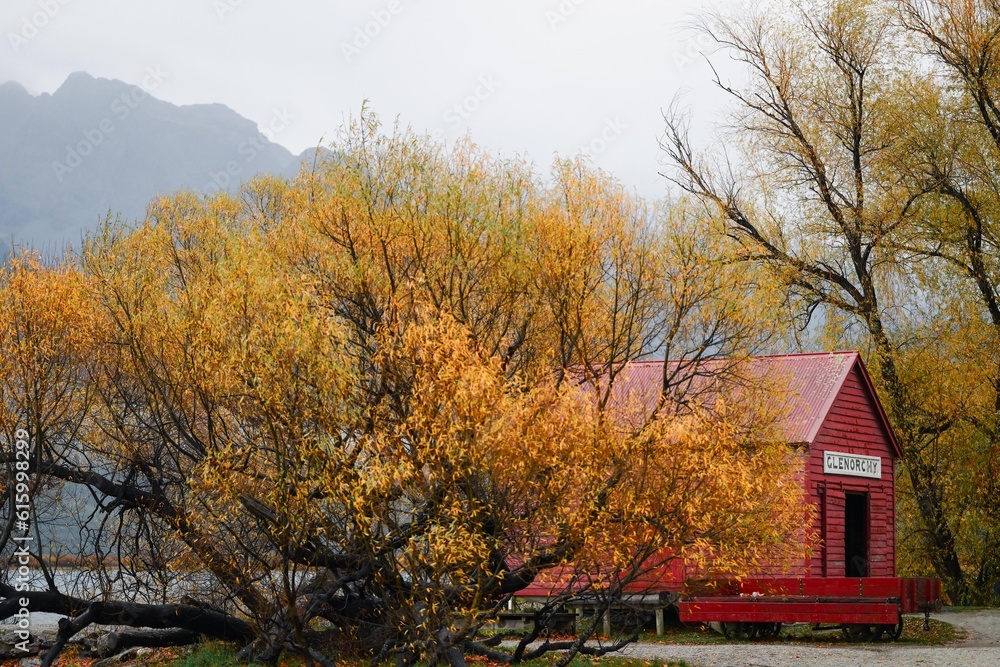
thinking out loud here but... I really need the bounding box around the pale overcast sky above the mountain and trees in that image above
[0,0,744,197]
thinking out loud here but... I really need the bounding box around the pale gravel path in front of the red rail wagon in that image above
[622,611,1000,667]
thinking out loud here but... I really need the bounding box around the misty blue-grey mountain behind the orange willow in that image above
[0,71,314,254]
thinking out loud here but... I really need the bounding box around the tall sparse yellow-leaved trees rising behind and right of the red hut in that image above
[663,0,1000,603]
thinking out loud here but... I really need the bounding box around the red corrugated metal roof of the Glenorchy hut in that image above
[613,352,899,452]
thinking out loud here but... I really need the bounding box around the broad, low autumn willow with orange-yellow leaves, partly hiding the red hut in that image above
[0,113,804,665]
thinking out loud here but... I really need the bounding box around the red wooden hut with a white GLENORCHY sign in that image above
[615,352,900,584]
